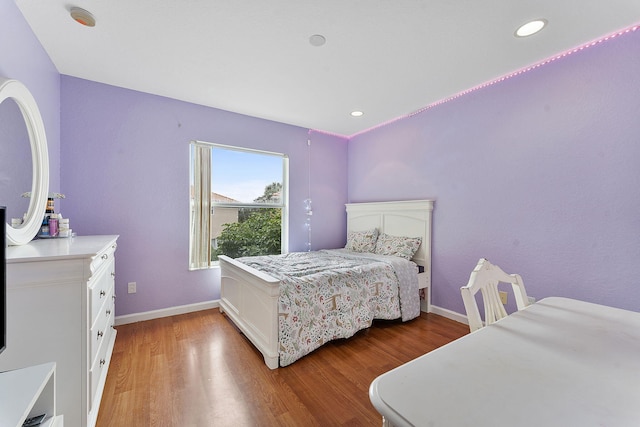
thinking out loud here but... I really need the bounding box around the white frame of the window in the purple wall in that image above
[189,141,289,270]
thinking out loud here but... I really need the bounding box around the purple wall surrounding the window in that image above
[61,76,347,315]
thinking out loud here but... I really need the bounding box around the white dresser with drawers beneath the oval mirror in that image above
[0,235,118,427]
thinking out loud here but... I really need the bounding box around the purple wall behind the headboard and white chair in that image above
[348,27,640,313]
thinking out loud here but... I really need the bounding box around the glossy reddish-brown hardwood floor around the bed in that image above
[97,310,469,427]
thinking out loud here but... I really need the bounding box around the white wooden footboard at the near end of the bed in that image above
[219,255,280,369]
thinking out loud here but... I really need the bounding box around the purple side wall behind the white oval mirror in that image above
[0,0,60,196]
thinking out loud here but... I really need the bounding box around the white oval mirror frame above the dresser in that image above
[0,77,49,245]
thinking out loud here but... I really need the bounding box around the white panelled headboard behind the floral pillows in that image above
[345,200,433,271]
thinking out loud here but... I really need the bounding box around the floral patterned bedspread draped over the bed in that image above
[238,249,420,366]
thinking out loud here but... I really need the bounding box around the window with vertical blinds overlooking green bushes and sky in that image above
[189,141,289,270]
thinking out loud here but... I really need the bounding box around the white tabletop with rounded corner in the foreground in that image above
[369,297,640,427]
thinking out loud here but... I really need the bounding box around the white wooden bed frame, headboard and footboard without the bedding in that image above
[219,200,433,369]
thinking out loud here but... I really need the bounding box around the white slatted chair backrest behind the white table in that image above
[460,258,529,332]
